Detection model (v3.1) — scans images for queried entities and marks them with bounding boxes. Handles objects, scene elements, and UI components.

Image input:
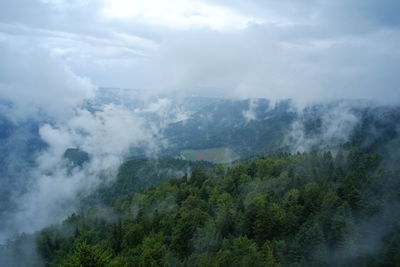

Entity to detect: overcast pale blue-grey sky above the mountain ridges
[0,0,400,103]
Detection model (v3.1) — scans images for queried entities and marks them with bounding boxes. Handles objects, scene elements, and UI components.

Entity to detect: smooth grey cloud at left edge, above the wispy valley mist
[0,44,95,118]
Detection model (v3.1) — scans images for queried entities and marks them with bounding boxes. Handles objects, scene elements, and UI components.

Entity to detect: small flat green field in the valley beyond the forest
[181,147,240,164]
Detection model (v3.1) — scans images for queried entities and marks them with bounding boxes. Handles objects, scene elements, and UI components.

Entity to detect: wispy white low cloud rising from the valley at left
[3,106,157,239]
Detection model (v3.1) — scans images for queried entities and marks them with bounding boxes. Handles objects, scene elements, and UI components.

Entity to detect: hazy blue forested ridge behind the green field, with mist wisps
[163,99,399,161]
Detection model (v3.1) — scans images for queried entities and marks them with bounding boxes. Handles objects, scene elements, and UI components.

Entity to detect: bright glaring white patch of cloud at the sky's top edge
[103,0,261,30]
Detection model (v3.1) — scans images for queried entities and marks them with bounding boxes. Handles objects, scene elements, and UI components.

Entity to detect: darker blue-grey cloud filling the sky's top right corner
[216,0,400,34]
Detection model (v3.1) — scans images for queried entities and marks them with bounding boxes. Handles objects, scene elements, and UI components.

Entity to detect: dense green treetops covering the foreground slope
[37,149,400,266]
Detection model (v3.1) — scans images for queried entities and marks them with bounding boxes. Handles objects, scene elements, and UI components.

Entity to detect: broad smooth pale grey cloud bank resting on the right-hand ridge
[134,23,400,103]
